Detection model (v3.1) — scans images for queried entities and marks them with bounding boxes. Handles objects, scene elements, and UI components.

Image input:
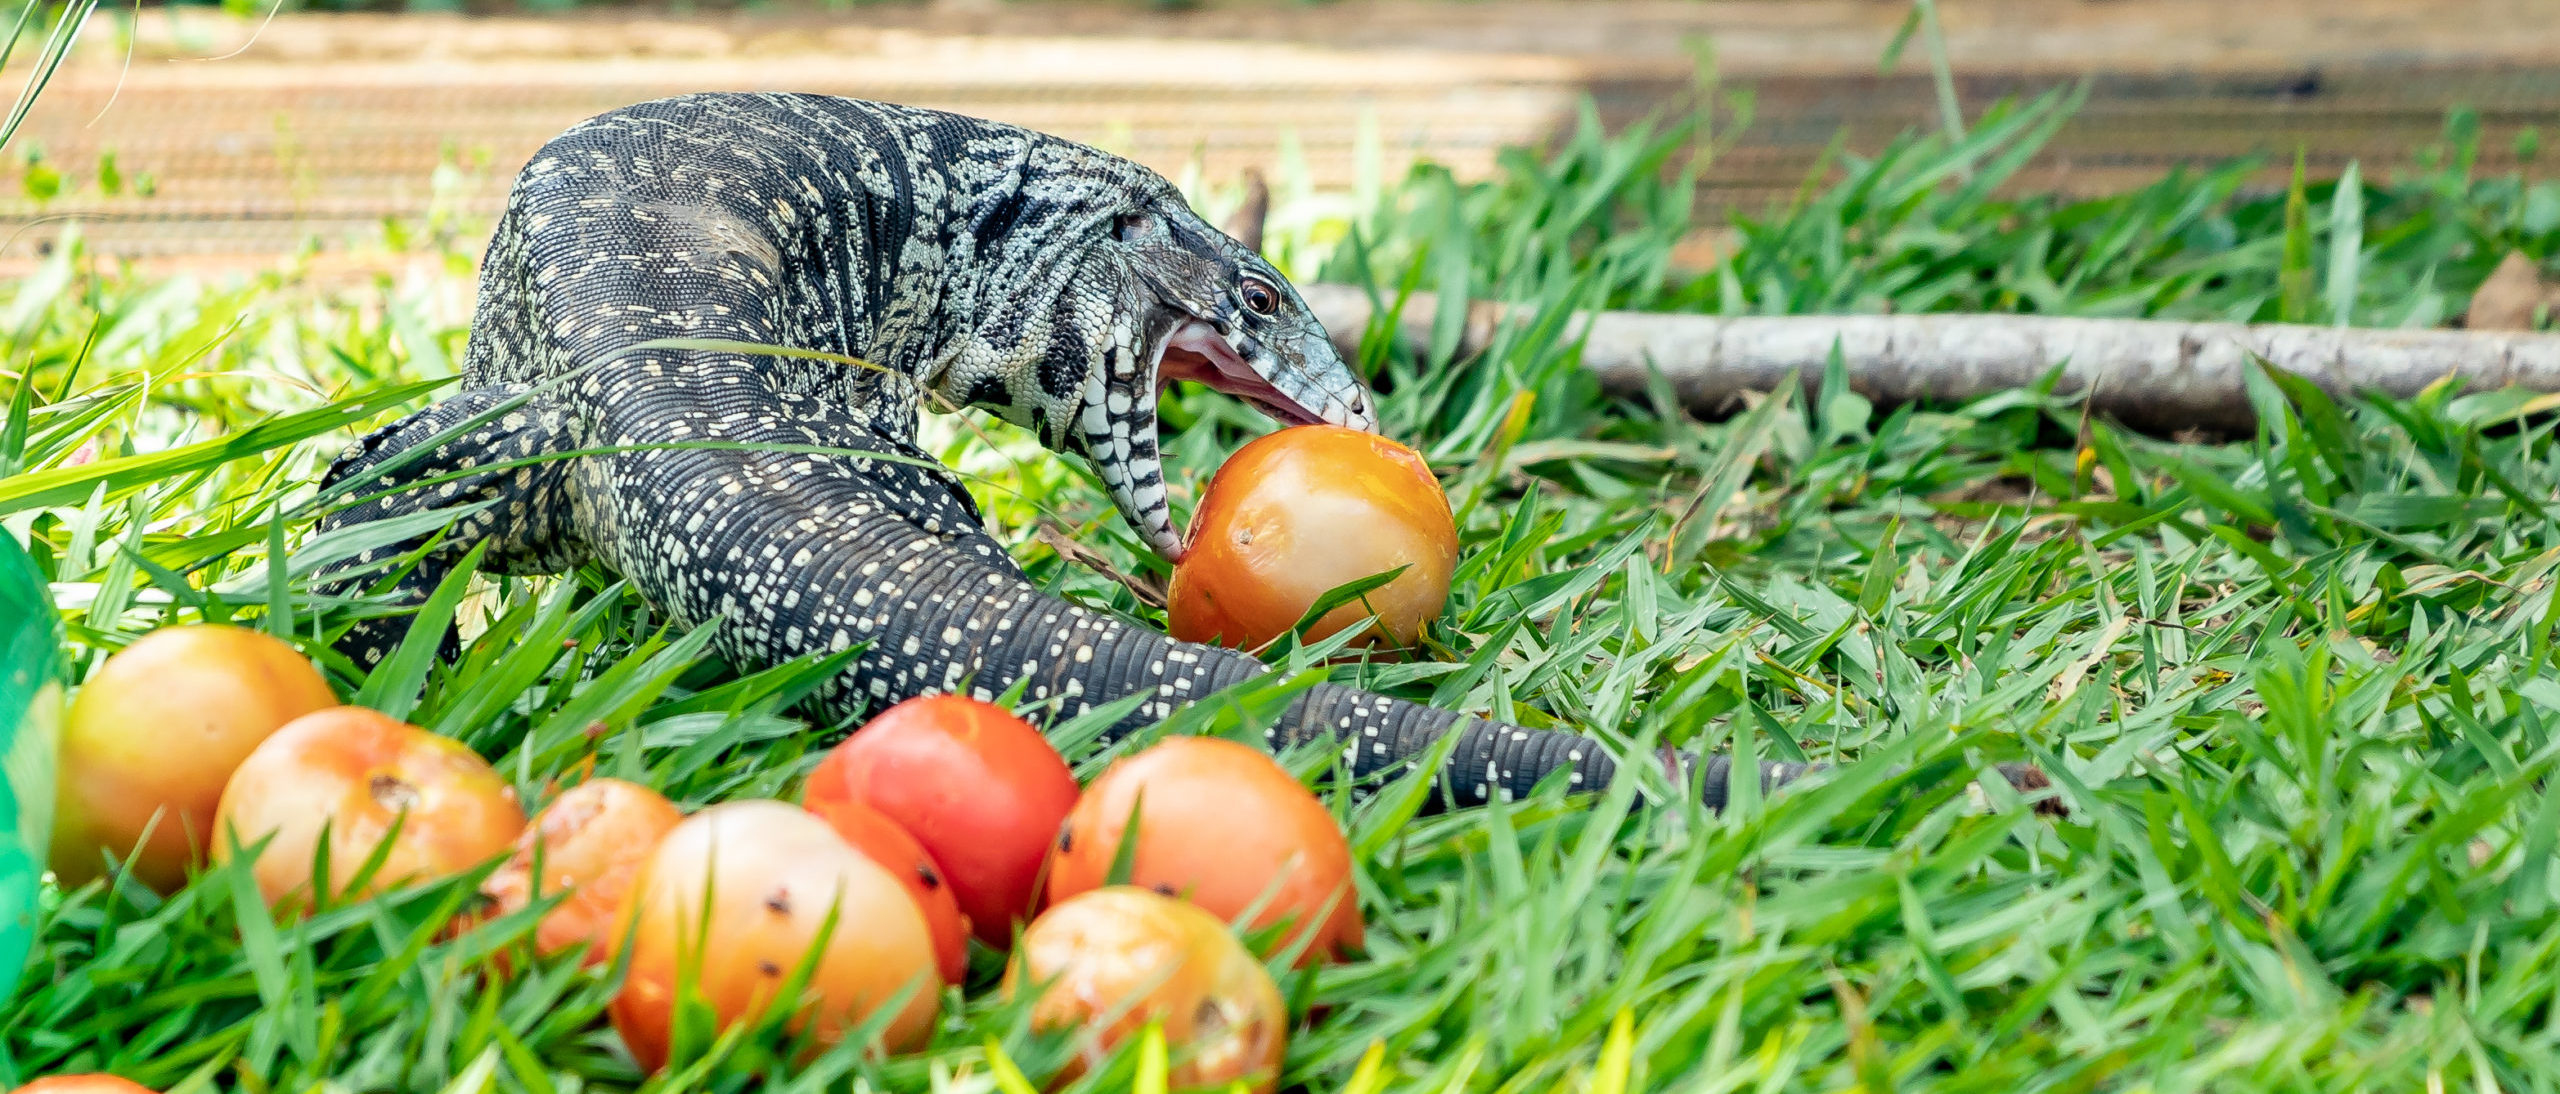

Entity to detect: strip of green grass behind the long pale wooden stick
[1326,90,2560,328]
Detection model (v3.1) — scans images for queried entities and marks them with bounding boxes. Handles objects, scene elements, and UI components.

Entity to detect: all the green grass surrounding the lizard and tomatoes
[15,79,2560,1094]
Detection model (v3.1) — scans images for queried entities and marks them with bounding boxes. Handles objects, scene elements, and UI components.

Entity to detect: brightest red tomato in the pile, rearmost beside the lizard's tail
[801,694,1075,951]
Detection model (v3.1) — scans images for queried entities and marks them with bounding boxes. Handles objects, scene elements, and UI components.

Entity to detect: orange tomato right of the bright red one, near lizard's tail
[1050,738,1362,963]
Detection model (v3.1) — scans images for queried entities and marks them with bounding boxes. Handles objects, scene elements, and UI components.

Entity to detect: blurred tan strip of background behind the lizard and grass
[0,0,2560,283]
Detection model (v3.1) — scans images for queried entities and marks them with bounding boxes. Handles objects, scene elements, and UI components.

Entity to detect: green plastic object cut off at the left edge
[0,535,64,1019]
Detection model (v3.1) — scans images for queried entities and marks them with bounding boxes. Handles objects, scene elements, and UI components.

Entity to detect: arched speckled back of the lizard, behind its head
[466,92,1170,417]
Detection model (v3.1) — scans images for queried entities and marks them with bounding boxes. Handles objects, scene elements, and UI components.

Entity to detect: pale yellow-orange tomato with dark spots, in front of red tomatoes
[612,802,942,1071]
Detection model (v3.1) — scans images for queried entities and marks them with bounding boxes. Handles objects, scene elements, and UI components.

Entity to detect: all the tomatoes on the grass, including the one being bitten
[20,428,1454,1091]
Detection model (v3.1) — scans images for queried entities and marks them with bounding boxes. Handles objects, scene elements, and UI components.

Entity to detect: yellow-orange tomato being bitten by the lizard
[1165,425,1457,648]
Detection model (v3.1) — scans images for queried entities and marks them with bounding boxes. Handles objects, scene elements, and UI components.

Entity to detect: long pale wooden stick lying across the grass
[1300,284,2560,433]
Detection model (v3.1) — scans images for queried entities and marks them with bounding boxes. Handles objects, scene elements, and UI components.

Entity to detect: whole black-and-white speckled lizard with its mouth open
[320,92,2020,810]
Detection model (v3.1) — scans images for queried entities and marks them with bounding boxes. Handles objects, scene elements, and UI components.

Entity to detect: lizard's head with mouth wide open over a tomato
[1013,187,1377,559]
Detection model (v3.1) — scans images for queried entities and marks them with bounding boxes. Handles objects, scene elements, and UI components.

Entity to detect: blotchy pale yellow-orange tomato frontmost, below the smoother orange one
[1004,886,1288,1094]
